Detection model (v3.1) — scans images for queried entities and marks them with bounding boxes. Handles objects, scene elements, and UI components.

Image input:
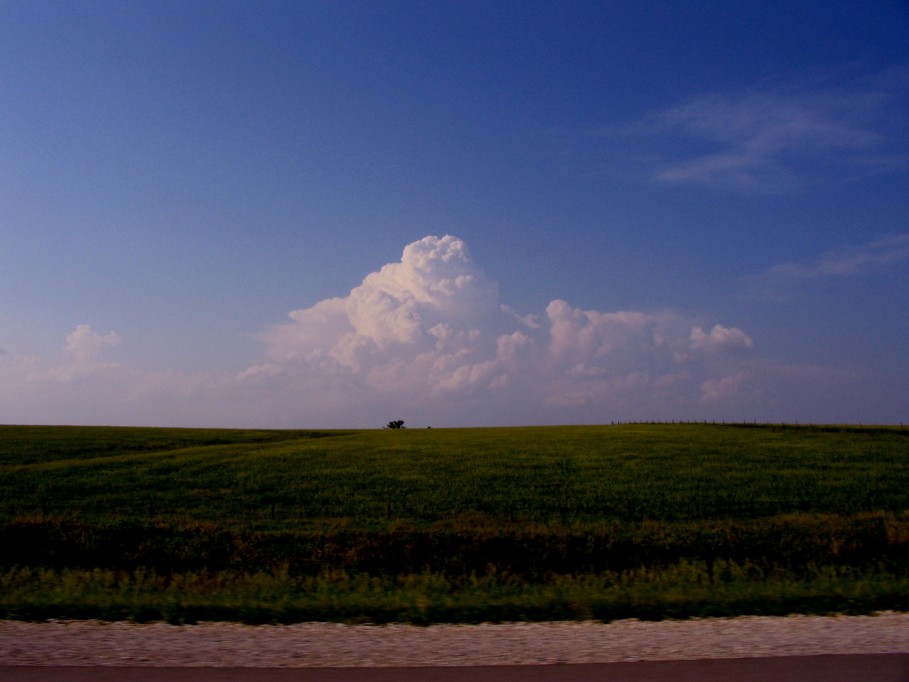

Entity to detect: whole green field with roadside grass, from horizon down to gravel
[0,424,909,623]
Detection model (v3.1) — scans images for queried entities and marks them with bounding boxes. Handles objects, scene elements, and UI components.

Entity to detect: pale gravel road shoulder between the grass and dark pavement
[0,612,909,668]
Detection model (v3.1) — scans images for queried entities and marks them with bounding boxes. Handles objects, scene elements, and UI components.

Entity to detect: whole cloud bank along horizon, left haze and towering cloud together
[0,235,888,428]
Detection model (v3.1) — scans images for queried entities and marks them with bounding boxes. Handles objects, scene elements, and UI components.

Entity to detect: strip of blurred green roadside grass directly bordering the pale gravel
[0,562,909,624]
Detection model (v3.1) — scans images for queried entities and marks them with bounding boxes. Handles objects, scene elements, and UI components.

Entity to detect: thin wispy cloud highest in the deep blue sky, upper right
[631,70,909,193]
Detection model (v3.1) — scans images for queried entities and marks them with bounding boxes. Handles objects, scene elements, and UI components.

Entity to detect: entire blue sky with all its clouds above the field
[0,0,909,427]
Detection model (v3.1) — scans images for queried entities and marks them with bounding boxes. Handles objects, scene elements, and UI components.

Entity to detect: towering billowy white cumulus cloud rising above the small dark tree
[240,235,753,422]
